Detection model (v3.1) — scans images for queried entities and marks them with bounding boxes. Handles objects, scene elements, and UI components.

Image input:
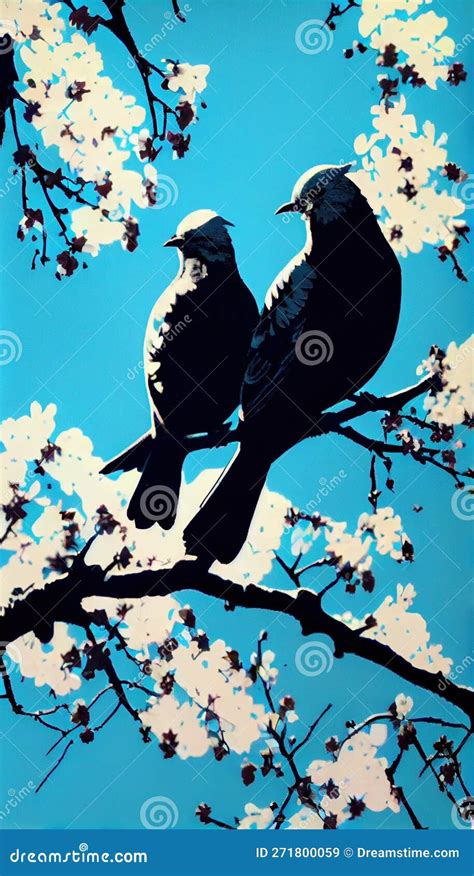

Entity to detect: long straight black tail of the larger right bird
[183,447,271,563]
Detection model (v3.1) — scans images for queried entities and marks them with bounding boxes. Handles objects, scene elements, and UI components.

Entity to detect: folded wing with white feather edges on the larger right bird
[242,252,316,419]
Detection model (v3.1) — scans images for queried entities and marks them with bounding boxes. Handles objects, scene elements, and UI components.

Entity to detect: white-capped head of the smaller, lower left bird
[163,210,234,263]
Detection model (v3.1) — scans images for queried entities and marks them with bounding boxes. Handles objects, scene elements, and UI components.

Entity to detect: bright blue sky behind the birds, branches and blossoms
[0,0,472,829]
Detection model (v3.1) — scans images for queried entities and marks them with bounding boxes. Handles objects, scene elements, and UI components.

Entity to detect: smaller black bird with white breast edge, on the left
[102,210,259,530]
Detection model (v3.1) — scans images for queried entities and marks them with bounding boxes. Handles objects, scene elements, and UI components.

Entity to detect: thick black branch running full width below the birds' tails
[0,558,474,723]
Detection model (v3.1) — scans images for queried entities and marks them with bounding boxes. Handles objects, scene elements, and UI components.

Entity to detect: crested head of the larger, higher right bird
[275,163,361,224]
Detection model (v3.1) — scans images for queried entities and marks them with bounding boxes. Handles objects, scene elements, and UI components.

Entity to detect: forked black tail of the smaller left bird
[102,429,186,529]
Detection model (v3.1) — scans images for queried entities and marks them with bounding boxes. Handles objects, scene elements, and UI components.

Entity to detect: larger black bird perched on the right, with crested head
[184,163,402,564]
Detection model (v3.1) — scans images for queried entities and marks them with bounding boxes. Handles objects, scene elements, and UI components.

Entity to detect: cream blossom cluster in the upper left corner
[0,0,210,270]
